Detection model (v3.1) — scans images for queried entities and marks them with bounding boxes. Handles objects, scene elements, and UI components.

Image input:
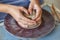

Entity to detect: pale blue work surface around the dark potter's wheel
[0,6,60,40]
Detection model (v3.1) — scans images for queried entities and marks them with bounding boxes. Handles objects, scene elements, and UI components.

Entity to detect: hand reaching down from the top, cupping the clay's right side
[28,0,42,22]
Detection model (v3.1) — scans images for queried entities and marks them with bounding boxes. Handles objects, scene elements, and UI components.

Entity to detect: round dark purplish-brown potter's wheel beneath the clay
[4,9,55,38]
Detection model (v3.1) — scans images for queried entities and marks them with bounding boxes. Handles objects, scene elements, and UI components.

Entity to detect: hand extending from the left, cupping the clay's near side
[5,5,36,28]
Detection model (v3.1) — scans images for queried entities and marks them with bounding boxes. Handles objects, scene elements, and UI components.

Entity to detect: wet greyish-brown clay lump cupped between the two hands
[21,10,42,29]
